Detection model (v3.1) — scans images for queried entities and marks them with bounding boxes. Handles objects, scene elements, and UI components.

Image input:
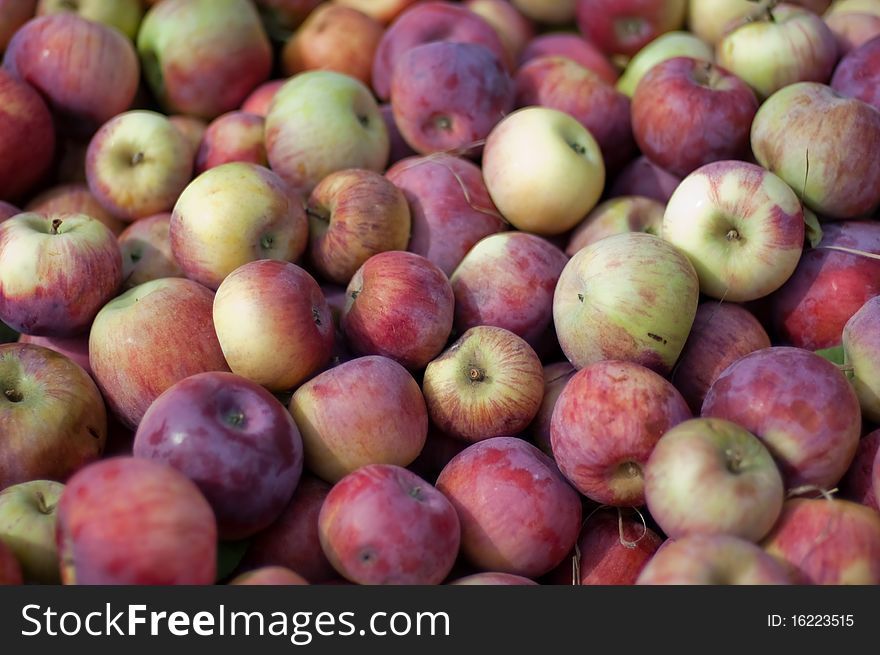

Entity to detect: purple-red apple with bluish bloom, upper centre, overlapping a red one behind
[390,41,514,154]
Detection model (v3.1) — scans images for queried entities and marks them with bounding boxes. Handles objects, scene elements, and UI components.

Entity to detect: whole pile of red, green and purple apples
[0,0,880,584]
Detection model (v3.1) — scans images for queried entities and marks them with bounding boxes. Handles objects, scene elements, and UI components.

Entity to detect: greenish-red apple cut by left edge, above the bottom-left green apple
[0,343,107,489]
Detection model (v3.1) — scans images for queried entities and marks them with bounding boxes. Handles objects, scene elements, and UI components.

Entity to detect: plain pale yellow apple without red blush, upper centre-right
[483,107,605,236]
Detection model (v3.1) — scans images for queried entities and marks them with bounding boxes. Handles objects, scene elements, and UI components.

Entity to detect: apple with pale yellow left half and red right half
[213,259,334,391]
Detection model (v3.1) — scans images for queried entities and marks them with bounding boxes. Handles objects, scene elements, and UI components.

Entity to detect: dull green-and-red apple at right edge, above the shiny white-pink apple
[752,82,880,219]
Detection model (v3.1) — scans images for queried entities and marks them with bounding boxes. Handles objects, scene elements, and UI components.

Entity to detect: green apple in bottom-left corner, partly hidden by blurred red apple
[0,480,64,584]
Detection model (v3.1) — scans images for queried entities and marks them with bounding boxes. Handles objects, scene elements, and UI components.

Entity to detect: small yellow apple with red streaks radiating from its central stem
[422,325,544,442]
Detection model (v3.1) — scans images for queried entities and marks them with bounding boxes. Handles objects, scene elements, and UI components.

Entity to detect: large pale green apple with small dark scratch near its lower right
[553,232,699,375]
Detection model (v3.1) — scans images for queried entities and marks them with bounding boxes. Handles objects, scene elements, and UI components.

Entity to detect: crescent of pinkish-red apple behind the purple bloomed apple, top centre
[372,2,512,100]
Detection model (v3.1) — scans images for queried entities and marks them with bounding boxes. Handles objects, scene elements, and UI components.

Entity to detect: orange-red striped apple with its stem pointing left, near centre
[306,168,411,285]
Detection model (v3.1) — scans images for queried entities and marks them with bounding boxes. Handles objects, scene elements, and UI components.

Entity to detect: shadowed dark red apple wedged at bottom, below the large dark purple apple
[239,472,338,584]
